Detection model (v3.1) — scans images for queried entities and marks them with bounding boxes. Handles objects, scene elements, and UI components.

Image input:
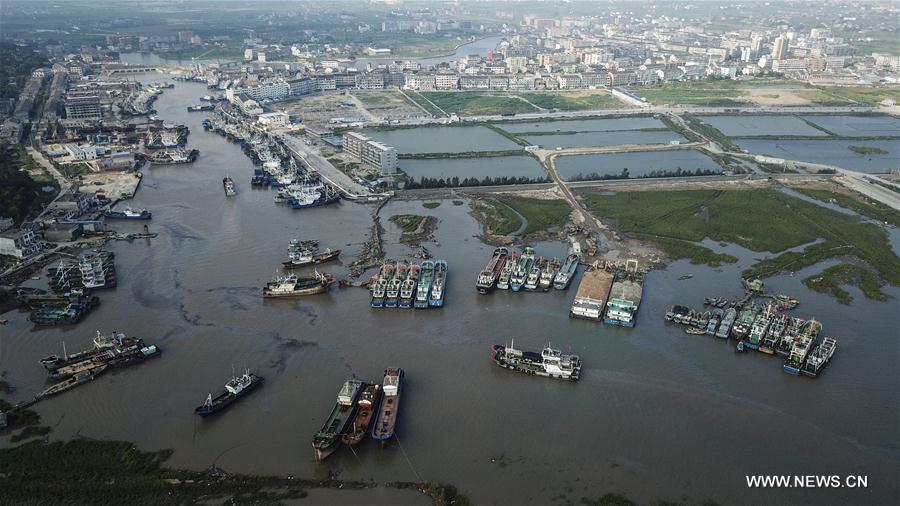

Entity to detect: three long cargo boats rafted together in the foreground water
[312,367,405,461]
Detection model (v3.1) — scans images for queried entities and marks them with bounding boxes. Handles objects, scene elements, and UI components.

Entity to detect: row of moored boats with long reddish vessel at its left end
[475,246,578,294]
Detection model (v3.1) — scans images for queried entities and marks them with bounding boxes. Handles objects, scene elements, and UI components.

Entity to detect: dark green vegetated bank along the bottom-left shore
[0,439,469,506]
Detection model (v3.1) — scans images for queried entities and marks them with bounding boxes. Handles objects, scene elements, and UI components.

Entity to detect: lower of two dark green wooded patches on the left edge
[0,143,59,223]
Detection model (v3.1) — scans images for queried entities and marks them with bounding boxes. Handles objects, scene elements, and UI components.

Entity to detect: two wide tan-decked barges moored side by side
[569,260,644,328]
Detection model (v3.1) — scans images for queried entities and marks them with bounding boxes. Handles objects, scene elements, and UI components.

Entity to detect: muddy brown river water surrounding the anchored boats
[0,83,900,504]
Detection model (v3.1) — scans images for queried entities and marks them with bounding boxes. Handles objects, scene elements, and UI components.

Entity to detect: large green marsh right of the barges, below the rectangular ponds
[585,189,900,296]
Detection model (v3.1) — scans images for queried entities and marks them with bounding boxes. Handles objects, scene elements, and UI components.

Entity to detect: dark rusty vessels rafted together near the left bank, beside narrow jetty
[35,332,160,400]
